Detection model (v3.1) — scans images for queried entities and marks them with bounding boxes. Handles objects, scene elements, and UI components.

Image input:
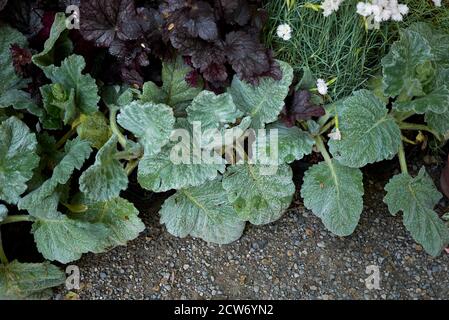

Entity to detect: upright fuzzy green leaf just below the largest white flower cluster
[382,30,434,97]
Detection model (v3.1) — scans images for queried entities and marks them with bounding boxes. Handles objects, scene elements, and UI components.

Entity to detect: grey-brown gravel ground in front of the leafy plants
[55,165,449,299]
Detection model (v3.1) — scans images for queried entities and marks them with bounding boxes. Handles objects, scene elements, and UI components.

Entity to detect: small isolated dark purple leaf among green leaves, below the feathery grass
[281,90,326,127]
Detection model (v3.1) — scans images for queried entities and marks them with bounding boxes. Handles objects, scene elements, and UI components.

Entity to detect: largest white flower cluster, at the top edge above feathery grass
[357,0,409,23]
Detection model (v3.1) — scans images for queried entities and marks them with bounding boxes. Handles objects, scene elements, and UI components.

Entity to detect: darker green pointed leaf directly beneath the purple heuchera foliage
[140,57,203,111]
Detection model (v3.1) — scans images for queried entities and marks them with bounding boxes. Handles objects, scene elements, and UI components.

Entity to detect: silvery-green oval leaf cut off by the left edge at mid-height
[0,117,39,204]
